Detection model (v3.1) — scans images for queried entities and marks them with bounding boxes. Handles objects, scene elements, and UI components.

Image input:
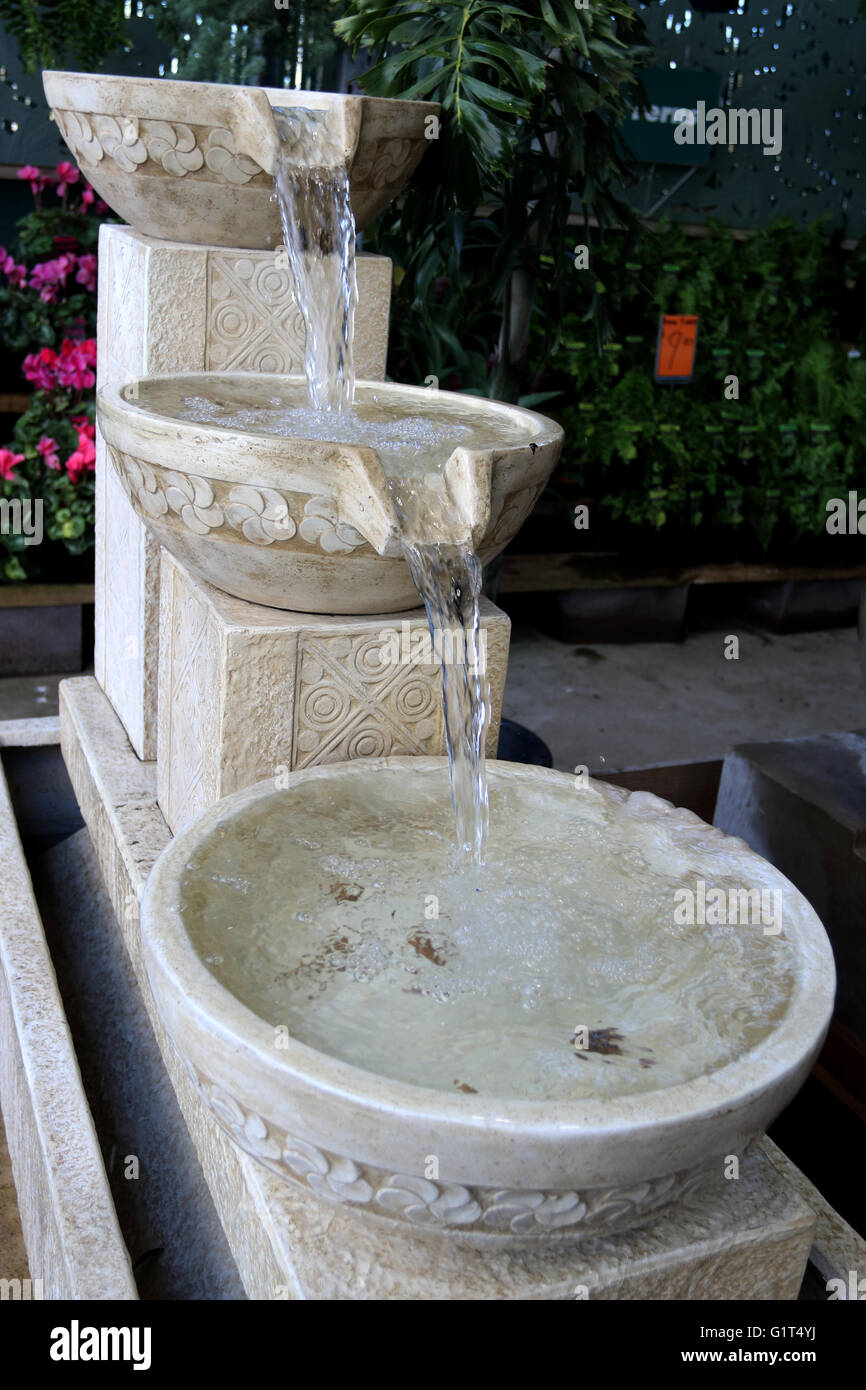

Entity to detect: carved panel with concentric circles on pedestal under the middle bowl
[292,634,442,767]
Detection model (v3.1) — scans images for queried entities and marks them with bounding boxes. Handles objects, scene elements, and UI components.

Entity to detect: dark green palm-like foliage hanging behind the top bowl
[335,0,649,398]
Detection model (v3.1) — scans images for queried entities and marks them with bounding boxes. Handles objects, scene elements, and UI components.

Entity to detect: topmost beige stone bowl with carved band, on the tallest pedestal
[43,72,439,250]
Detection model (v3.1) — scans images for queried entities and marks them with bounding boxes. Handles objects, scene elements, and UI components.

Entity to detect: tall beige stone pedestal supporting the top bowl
[95,225,391,759]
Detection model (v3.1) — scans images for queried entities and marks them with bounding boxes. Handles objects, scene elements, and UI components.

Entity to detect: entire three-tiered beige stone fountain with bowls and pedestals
[44,74,833,1298]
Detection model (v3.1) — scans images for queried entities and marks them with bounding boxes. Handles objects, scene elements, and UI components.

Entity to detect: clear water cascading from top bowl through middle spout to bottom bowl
[274,107,489,865]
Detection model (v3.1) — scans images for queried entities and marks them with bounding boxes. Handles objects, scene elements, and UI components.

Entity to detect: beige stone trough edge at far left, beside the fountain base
[0,745,138,1300]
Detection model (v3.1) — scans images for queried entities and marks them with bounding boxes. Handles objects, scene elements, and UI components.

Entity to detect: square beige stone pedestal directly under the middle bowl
[157,550,512,833]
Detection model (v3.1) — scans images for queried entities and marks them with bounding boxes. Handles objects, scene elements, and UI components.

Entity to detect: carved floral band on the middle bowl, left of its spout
[108,448,367,555]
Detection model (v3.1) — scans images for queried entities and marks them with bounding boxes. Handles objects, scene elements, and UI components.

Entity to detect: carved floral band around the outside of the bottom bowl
[185,1062,708,1240]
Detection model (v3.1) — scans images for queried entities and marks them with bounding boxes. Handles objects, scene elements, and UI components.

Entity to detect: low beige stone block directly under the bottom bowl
[261,1148,815,1301]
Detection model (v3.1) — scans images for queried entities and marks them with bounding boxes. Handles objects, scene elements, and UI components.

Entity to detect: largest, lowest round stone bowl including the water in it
[142,759,834,1245]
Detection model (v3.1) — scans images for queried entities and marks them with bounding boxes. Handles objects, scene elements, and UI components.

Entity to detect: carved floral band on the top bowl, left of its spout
[54,111,267,183]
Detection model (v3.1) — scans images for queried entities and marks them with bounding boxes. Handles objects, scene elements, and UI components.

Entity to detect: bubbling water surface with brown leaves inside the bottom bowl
[181,766,796,1099]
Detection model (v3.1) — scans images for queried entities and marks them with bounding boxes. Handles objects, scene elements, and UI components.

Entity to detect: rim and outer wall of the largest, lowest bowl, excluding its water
[142,758,835,1238]
